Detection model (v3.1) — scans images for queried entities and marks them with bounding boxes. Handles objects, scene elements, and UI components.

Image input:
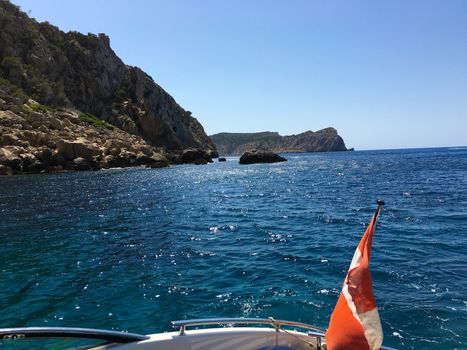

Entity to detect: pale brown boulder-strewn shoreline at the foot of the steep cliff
[0,89,217,175]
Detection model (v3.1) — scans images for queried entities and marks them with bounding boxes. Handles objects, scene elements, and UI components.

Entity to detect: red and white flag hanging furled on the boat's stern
[326,206,383,350]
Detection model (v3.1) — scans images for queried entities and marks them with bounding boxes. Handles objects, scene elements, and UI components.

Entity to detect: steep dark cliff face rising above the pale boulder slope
[0,1,215,151]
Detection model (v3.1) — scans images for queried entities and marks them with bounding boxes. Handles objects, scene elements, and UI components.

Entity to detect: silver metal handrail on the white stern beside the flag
[172,317,325,336]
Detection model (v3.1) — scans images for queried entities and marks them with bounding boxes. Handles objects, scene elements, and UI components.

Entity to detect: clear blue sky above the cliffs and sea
[13,0,467,149]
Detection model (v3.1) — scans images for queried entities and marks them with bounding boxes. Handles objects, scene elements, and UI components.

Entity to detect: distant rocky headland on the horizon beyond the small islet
[210,128,347,155]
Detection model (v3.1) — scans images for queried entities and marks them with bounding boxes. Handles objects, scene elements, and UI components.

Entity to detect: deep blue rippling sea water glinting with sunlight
[0,148,467,349]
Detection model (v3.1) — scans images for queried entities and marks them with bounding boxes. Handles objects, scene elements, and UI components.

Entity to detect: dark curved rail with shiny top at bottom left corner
[0,327,149,343]
